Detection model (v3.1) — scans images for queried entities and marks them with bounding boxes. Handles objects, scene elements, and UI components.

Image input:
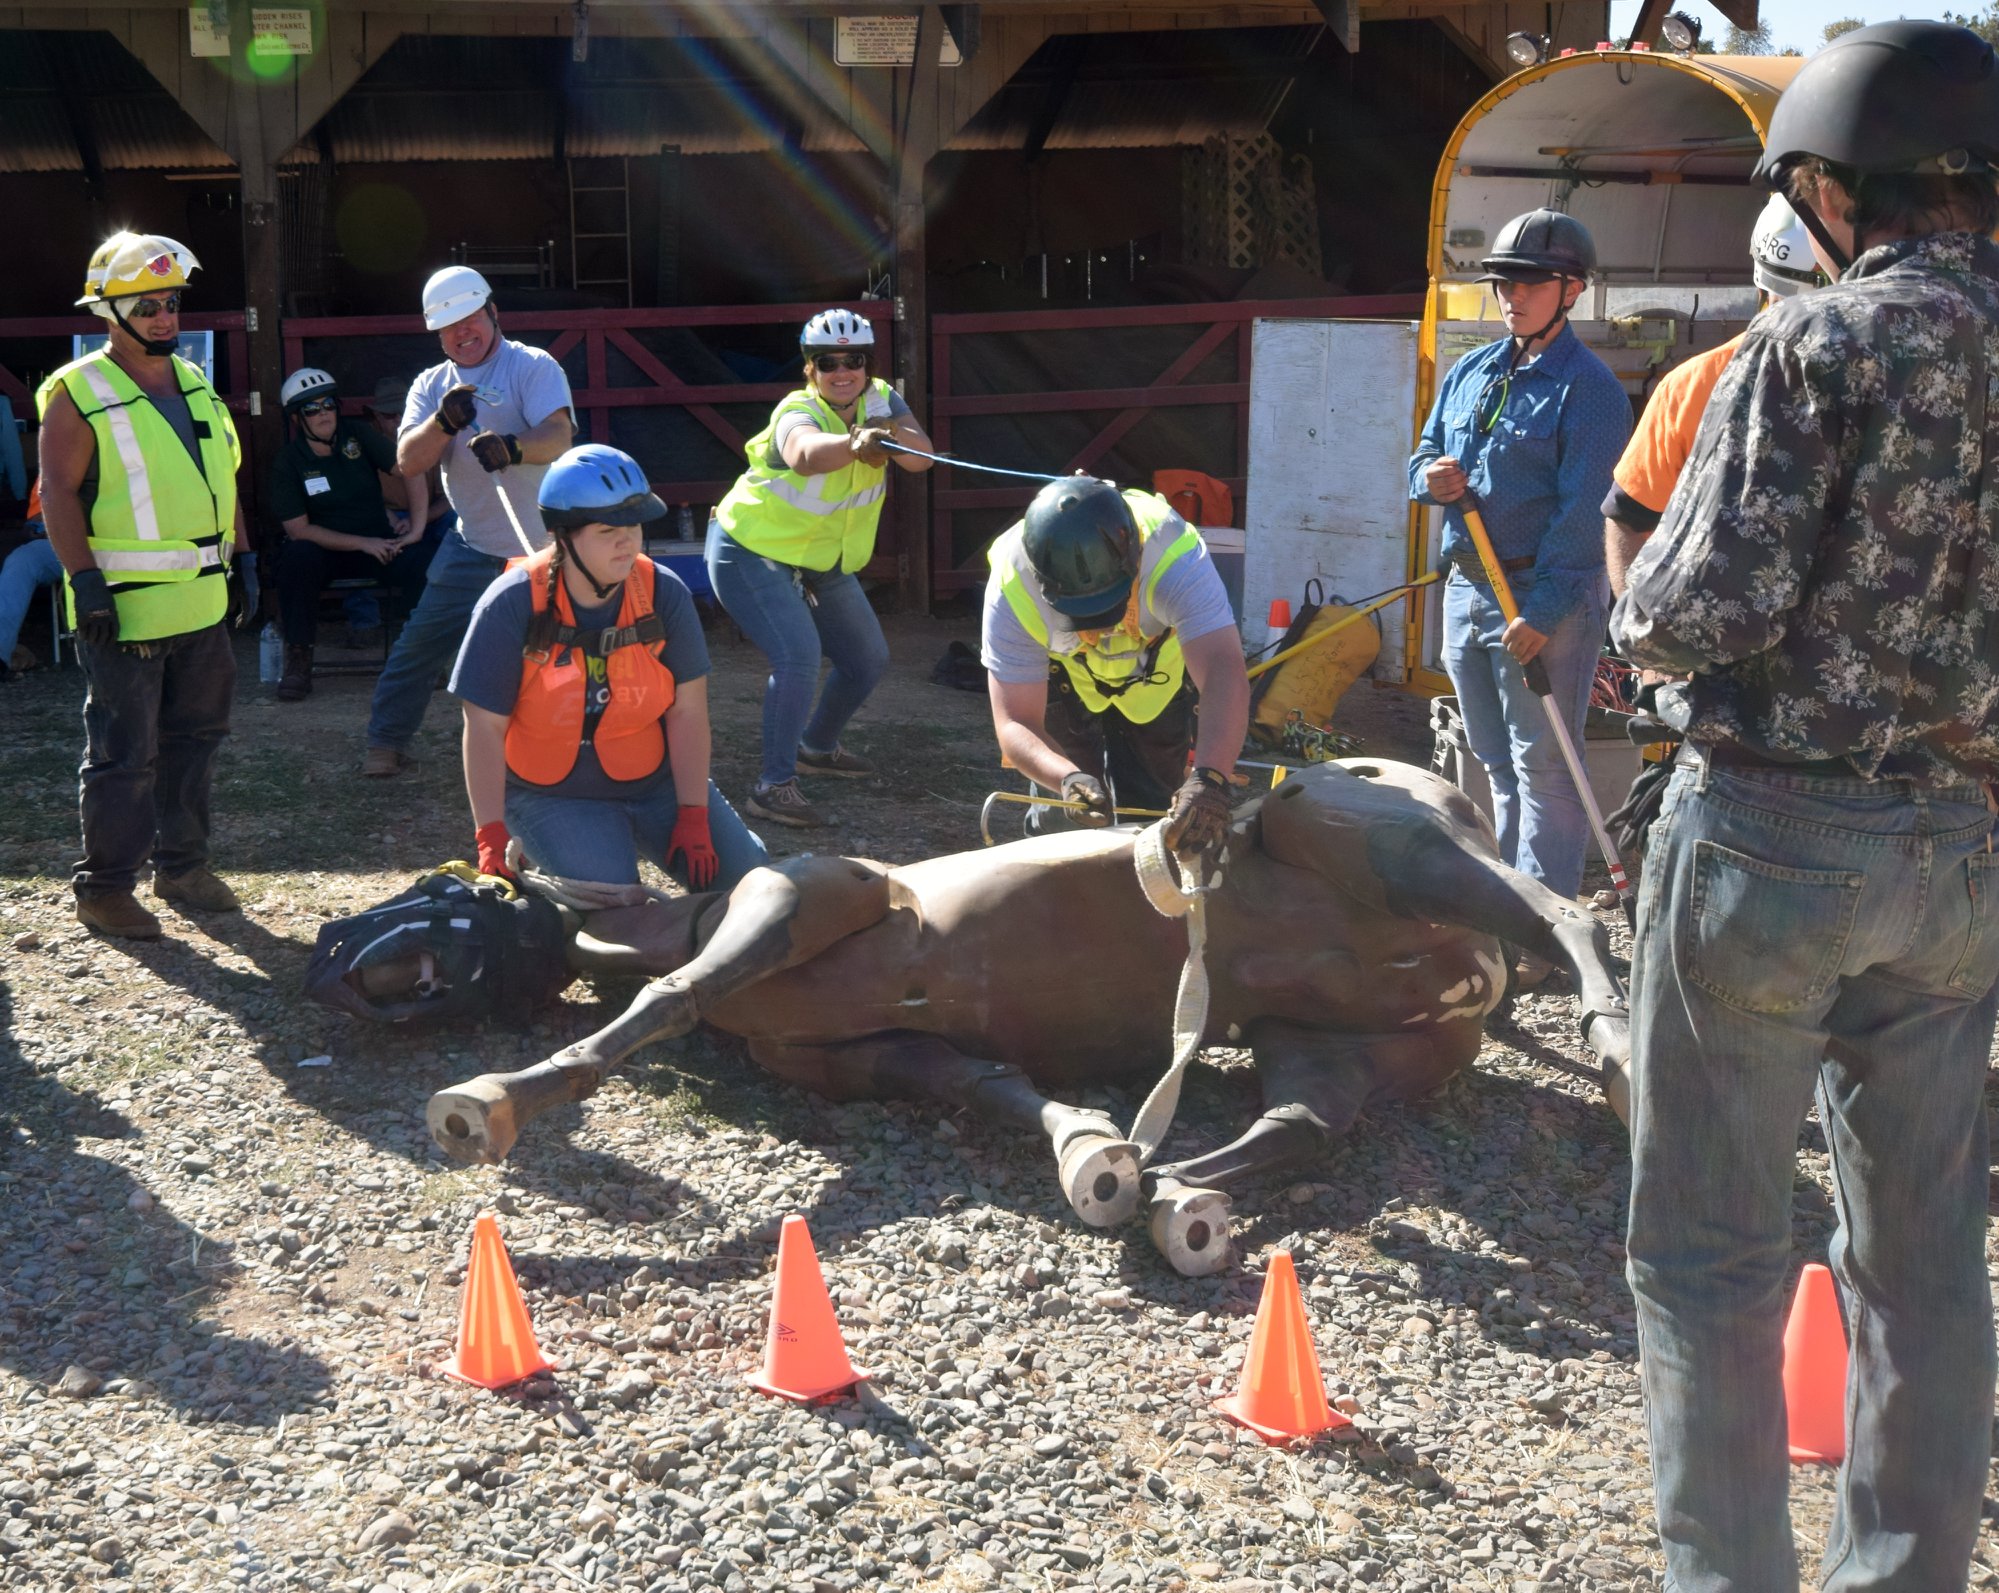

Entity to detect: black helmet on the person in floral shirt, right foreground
[1755,22,1999,188]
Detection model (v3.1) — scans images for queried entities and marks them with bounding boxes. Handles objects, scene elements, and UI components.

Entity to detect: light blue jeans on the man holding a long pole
[1443,574,1609,897]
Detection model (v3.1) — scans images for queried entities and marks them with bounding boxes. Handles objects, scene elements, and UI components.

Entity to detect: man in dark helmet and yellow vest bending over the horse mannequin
[980,476,1249,851]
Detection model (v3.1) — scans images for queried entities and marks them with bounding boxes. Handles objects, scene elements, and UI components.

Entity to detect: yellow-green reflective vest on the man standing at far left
[34,348,242,642]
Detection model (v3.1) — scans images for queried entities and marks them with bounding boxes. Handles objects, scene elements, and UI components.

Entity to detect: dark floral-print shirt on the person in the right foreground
[1613,232,1999,786]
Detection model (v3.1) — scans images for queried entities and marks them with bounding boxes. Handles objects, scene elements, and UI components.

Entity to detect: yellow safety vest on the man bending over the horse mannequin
[986,488,1201,726]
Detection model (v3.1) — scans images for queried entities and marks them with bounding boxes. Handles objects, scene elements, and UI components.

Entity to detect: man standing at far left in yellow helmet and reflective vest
[34,232,242,939]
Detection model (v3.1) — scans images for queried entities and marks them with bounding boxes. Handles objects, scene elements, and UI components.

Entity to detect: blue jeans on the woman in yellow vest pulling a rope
[706,520,888,786]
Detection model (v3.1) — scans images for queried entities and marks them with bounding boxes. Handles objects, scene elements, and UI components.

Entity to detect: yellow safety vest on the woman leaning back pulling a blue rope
[716,378,896,574]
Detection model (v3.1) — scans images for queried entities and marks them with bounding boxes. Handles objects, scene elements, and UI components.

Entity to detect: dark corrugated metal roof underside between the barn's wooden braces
[0,28,1313,172]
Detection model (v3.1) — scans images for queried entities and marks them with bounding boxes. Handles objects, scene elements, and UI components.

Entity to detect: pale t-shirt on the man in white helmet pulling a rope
[396,338,574,558]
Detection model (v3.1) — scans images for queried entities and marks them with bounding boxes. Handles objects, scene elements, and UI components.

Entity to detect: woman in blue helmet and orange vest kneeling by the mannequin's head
[452,446,766,889]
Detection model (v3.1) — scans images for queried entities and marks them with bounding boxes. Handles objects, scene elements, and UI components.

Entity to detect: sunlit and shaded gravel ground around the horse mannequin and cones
[0,620,1999,1593]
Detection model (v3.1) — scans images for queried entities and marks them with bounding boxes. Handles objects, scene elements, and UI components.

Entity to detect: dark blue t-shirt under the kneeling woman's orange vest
[452,564,708,799]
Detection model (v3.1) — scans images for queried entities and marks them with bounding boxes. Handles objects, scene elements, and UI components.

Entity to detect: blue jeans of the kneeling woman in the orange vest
[506,780,770,891]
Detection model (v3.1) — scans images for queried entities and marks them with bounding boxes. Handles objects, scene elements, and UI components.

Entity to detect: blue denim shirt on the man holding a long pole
[1409,326,1631,636]
